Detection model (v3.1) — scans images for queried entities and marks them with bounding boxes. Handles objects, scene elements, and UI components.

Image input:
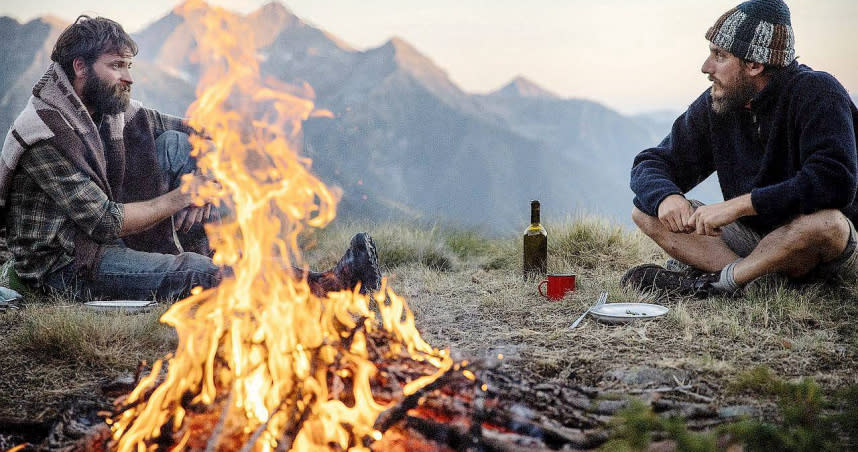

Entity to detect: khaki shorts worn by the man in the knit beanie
[690,199,858,282]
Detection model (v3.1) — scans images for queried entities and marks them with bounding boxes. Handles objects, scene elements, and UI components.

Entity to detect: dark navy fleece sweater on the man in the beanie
[631,62,858,234]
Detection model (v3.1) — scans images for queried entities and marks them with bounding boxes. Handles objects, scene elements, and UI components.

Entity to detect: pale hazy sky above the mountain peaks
[0,0,858,113]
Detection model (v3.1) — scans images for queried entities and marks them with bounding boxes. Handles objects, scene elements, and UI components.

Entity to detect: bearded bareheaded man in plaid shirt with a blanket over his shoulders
[0,16,381,300]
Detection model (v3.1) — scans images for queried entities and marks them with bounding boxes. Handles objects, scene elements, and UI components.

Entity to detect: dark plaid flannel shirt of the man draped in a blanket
[6,108,190,287]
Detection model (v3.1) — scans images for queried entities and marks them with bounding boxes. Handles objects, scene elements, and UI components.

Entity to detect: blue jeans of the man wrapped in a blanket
[43,131,222,300]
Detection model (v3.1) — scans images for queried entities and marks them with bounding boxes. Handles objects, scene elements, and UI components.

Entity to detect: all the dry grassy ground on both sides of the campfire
[0,218,858,450]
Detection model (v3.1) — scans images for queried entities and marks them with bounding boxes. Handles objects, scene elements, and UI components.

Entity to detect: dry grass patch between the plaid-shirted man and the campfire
[0,300,176,421]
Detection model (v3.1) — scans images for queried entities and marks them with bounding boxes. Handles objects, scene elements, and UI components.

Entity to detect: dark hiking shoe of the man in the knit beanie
[620,264,720,298]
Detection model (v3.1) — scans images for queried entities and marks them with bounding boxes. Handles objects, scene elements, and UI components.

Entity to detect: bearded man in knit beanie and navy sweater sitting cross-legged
[622,0,858,297]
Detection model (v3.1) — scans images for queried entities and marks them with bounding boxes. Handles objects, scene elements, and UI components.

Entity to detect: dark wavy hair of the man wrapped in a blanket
[51,15,137,81]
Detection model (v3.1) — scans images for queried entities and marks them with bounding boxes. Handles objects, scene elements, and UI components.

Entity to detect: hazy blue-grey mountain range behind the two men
[0,2,736,231]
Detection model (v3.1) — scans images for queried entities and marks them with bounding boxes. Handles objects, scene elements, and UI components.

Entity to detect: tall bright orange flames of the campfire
[109,0,452,451]
